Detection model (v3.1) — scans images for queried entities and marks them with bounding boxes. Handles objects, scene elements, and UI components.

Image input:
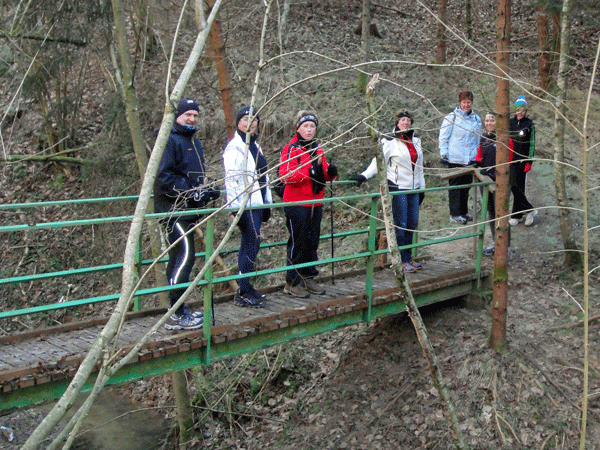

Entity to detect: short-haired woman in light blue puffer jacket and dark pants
[439,91,481,225]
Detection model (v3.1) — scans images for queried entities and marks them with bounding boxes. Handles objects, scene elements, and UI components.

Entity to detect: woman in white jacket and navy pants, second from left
[223,106,273,308]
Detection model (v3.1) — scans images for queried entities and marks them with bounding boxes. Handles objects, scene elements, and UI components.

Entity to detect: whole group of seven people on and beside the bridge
[154,91,536,330]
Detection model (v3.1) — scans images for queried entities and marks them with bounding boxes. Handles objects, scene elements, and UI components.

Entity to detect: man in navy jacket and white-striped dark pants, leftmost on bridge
[154,98,220,330]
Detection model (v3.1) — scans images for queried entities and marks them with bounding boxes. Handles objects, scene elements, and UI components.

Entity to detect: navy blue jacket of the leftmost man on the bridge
[154,122,206,219]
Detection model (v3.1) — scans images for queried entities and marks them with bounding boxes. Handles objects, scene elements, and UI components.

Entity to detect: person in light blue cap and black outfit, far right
[508,95,537,227]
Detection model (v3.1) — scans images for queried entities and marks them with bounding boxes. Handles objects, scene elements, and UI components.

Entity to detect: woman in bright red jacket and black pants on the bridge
[279,111,338,298]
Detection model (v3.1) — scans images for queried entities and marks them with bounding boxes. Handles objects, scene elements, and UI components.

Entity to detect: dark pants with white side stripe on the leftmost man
[165,218,196,313]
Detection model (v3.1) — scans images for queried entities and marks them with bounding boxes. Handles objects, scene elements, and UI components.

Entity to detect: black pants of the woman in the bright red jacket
[284,206,323,286]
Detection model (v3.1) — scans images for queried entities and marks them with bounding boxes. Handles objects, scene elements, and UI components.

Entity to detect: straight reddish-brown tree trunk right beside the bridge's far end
[488,0,510,351]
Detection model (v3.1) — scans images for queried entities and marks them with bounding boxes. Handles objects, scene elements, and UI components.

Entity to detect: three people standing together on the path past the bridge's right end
[439,91,537,255]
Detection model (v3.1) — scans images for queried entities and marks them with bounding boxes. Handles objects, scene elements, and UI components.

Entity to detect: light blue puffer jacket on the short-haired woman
[439,107,481,165]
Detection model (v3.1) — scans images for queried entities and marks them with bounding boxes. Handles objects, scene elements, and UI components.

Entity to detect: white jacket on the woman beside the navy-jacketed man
[223,132,273,208]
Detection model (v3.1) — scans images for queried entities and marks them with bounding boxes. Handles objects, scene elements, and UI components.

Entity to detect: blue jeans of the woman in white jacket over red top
[390,188,419,263]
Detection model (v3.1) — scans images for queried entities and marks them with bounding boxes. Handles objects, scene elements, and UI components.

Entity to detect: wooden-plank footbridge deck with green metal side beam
[0,181,488,411]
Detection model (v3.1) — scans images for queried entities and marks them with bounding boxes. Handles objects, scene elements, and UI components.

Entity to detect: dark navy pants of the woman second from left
[238,209,262,294]
